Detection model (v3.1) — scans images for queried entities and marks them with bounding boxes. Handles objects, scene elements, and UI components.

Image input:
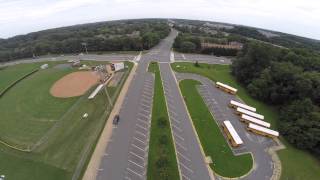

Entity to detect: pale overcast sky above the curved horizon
[0,0,320,40]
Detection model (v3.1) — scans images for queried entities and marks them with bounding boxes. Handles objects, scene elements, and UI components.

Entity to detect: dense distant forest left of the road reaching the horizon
[0,19,170,62]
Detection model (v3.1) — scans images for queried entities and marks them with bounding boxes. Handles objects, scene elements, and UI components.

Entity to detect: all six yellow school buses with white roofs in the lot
[216,82,279,147]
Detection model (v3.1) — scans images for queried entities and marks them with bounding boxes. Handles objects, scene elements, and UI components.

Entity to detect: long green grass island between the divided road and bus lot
[179,79,253,178]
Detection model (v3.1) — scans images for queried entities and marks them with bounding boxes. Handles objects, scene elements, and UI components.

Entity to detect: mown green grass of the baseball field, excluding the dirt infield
[0,62,132,180]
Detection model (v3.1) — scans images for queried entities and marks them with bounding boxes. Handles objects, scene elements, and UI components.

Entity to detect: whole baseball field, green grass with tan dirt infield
[0,61,132,180]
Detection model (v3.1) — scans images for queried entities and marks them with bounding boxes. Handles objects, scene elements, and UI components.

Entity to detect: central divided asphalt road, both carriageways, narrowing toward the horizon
[97,31,214,180]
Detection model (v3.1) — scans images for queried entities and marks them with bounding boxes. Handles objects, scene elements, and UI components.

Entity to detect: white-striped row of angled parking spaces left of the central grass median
[124,76,154,180]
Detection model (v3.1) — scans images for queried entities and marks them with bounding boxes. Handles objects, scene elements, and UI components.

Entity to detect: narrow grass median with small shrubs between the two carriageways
[147,63,180,180]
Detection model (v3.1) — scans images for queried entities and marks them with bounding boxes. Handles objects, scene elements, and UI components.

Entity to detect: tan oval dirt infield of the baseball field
[50,71,99,98]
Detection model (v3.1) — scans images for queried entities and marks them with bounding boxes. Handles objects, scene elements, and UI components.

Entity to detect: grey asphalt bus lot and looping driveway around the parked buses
[176,73,276,180]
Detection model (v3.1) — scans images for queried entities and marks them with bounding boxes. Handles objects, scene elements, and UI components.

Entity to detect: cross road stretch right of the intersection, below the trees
[174,52,232,64]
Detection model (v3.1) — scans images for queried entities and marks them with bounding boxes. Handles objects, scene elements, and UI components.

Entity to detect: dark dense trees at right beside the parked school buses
[232,42,320,157]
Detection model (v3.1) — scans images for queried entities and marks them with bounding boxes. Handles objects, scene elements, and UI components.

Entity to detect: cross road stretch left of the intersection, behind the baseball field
[0,54,138,67]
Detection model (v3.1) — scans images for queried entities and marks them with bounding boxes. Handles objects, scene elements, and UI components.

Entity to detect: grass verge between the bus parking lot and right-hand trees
[171,63,320,180]
